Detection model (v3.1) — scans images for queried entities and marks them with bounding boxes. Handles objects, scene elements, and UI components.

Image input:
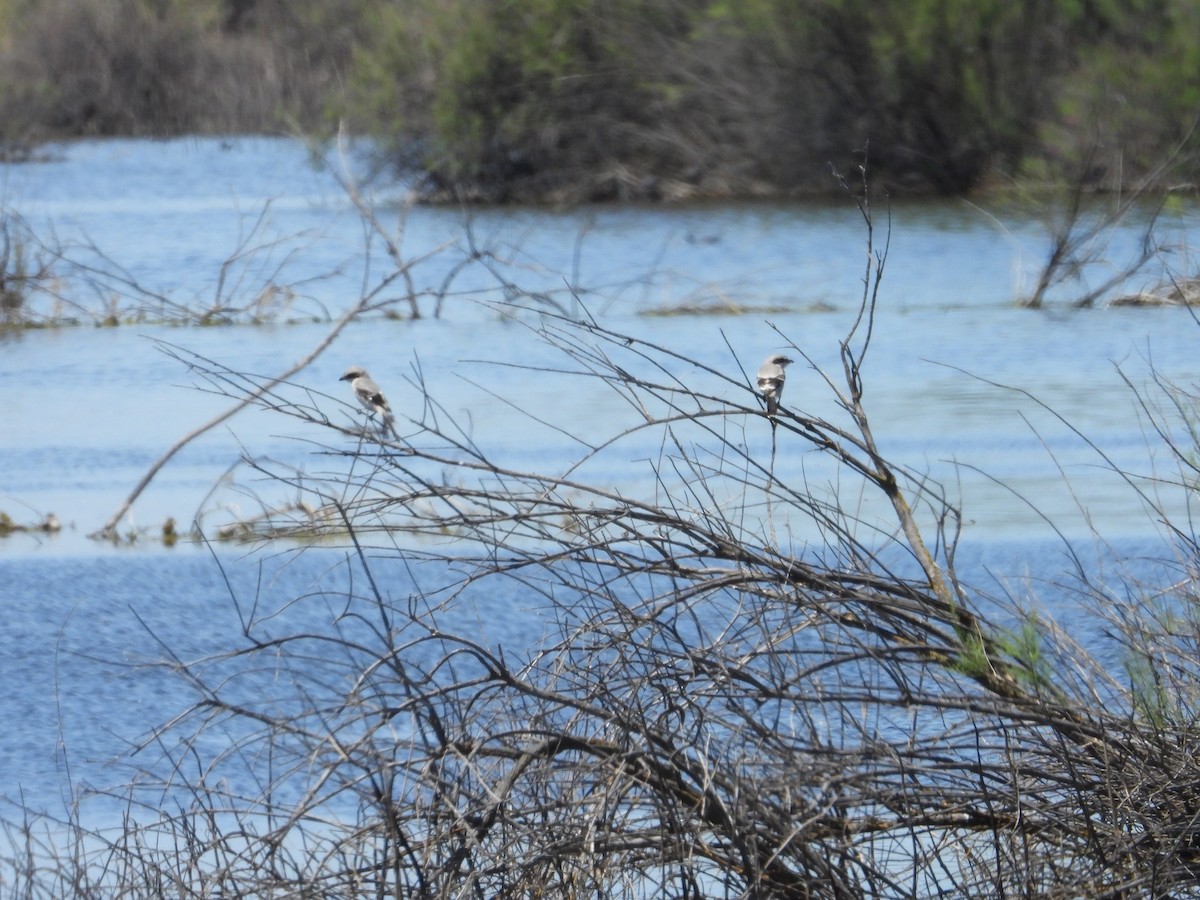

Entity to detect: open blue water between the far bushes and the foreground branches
[0,139,1200,825]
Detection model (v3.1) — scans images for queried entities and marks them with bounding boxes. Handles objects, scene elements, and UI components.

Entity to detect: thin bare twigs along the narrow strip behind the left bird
[0,158,590,329]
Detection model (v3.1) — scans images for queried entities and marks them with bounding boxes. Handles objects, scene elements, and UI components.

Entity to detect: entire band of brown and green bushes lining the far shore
[0,0,1200,200]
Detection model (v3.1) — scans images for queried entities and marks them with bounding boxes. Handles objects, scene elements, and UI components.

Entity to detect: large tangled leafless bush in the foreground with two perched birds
[7,168,1200,898]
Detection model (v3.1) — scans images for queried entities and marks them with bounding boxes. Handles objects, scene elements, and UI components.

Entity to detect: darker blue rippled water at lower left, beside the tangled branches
[0,548,546,812]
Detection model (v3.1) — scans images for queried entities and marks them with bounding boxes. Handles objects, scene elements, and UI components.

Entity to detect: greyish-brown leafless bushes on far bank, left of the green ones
[0,0,367,146]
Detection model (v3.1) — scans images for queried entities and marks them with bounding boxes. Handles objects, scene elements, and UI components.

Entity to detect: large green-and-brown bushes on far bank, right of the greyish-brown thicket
[336,0,1198,199]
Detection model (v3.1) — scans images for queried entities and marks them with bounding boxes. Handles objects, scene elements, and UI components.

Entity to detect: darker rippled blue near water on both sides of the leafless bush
[0,541,1182,823]
